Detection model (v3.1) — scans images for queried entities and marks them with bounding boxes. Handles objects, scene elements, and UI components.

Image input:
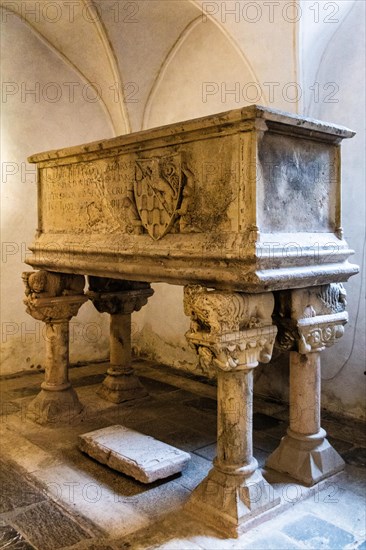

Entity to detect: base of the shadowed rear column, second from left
[97,369,148,403]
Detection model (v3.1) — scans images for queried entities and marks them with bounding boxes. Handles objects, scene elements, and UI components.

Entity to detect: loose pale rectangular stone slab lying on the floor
[79,425,191,483]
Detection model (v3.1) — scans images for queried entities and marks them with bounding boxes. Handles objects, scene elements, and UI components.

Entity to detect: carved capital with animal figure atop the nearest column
[184,286,277,376]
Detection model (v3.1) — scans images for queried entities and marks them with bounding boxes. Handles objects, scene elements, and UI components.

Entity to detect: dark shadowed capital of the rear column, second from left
[86,277,154,315]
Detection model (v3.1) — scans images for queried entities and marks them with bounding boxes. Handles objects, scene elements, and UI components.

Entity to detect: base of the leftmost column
[27,385,84,424]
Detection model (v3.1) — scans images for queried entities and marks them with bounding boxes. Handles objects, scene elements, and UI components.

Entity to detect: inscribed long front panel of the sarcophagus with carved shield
[40,136,240,241]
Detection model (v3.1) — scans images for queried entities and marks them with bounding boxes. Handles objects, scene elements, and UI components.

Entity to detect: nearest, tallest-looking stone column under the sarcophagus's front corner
[185,286,280,536]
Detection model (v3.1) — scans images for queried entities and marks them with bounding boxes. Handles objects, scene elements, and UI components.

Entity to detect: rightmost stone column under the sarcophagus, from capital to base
[266,284,348,485]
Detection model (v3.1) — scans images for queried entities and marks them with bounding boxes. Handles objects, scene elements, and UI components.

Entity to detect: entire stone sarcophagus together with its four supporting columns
[23,106,358,535]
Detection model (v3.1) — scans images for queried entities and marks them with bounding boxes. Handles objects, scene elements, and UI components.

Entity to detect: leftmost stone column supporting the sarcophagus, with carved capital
[23,271,87,424]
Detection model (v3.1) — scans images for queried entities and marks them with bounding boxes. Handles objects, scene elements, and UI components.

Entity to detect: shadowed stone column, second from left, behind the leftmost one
[87,277,154,403]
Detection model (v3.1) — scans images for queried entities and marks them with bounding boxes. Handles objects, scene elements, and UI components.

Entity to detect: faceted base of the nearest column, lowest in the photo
[185,468,281,537]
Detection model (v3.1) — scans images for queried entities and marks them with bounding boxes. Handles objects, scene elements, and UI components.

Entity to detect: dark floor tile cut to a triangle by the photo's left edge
[0,461,45,513]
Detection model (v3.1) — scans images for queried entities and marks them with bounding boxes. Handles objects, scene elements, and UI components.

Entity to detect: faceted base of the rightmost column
[266,428,345,486]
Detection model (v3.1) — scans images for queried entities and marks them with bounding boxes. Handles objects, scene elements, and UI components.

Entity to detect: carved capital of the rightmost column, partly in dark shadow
[275,283,348,354]
